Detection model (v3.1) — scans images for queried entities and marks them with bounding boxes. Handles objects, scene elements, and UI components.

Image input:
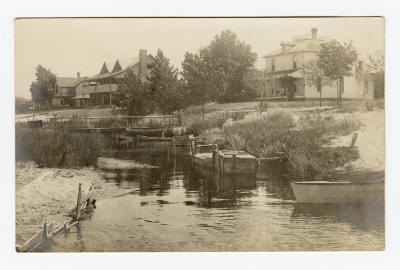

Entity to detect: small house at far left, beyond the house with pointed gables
[52,72,84,107]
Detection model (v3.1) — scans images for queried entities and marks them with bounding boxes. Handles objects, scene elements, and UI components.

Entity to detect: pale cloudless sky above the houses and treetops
[15,17,384,98]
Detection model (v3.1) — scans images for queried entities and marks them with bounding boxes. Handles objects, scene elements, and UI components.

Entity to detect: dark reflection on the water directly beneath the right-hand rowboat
[292,202,385,231]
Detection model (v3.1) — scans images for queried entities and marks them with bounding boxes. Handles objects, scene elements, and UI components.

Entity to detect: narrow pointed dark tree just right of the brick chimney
[149,49,185,114]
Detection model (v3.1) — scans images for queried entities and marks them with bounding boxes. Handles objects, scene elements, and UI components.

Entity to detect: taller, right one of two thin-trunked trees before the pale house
[319,39,357,104]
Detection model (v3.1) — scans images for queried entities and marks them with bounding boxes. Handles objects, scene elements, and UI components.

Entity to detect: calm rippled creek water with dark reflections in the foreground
[42,144,384,251]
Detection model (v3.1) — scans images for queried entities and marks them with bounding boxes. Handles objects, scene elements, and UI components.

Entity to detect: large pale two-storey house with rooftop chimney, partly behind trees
[261,28,374,100]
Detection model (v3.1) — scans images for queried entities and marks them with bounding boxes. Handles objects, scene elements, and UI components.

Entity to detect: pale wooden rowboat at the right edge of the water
[290,180,385,204]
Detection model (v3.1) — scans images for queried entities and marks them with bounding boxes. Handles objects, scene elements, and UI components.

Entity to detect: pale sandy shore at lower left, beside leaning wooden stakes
[15,163,102,244]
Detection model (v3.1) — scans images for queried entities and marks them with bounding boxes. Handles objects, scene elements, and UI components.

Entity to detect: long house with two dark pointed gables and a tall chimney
[73,50,155,107]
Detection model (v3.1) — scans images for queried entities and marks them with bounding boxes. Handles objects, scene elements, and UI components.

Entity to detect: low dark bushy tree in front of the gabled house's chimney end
[113,69,153,115]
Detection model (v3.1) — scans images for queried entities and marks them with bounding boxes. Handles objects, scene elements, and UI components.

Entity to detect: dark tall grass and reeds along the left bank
[15,124,111,168]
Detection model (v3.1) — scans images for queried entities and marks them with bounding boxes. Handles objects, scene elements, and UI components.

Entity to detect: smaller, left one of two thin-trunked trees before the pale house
[304,60,332,107]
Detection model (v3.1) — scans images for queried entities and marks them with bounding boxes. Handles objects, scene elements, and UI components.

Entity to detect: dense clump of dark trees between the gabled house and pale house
[113,30,257,115]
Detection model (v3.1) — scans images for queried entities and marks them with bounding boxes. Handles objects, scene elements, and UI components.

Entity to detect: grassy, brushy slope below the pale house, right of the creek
[199,110,361,180]
